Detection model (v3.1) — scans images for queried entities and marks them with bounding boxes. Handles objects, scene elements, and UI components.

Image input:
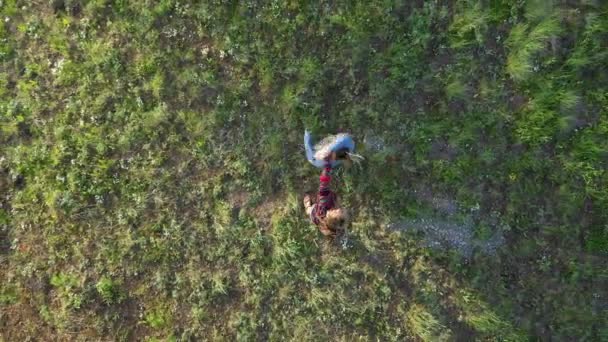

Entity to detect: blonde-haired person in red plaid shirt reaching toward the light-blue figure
[304,149,350,237]
